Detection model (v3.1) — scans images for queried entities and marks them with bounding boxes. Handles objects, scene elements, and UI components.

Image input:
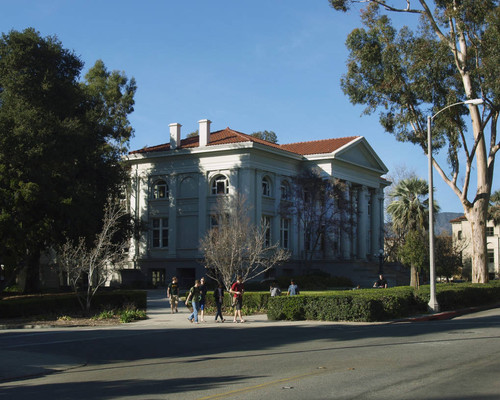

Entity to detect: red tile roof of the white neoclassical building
[129,128,359,155]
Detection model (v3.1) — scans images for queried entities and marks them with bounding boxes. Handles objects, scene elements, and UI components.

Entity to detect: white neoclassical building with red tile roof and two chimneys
[126,120,389,285]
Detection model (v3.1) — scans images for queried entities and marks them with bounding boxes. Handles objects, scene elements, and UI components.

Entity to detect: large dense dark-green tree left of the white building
[0,28,136,291]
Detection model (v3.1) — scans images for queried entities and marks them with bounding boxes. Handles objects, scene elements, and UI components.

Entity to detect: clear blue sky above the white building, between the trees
[0,0,492,212]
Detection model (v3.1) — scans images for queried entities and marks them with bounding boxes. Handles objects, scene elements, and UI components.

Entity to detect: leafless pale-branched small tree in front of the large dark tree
[57,199,129,312]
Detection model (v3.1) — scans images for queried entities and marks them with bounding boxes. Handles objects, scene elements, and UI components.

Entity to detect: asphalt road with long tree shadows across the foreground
[0,290,500,400]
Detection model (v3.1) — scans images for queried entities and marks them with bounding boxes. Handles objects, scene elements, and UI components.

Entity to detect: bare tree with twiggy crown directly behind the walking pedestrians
[201,195,289,290]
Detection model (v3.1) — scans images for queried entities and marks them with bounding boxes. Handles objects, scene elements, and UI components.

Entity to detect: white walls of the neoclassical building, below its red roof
[124,136,385,284]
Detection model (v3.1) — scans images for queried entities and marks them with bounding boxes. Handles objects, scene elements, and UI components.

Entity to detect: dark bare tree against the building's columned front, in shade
[280,169,353,265]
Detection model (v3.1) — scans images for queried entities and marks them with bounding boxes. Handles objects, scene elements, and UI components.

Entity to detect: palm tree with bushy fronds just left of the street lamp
[387,177,439,288]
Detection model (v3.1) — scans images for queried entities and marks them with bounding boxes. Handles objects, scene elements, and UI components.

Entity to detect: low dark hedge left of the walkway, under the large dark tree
[0,290,147,318]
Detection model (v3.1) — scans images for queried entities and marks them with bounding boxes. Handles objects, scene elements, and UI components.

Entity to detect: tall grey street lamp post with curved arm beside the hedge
[427,99,483,312]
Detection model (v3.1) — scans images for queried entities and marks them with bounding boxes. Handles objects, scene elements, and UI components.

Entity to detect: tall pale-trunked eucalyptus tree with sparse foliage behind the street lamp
[329,0,500,283]
